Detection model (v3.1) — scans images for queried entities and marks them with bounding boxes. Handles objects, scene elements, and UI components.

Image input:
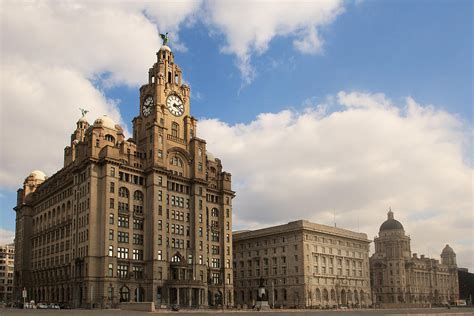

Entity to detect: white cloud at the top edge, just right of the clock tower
[205,0,343,84]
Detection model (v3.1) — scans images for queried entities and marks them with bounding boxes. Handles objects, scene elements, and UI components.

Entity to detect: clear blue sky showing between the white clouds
[105,1,472,128]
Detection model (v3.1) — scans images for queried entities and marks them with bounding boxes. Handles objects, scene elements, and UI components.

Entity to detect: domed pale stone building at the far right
[370,210,459,307]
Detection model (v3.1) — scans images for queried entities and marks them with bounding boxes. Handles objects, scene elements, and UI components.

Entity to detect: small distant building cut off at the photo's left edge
[0,244,15,302]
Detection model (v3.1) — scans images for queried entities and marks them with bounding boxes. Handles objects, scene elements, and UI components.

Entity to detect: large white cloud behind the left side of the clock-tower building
[0,0,200,189]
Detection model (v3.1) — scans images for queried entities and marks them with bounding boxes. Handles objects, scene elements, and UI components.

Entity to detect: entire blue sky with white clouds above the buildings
[0,0,474,270]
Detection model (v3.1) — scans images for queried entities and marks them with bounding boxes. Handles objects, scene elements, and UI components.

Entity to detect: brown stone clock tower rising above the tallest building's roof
[133,45,198,168]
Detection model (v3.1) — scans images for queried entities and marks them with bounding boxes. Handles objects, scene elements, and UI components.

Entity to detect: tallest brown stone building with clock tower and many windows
[15,46,234,307]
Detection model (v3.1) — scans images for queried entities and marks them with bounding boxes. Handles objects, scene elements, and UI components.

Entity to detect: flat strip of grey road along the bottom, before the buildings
[0,307,474,316]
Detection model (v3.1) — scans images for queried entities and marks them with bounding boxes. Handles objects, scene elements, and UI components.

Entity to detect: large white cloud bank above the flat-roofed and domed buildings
[198,91,474,269]
